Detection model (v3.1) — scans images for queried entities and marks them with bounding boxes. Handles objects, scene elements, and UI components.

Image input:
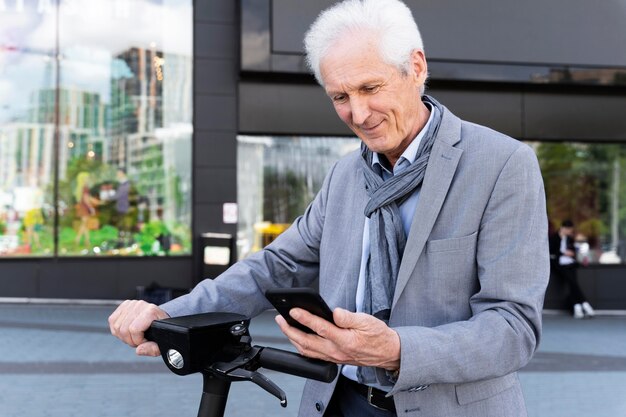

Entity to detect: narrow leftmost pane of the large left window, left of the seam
[0,1,56,256]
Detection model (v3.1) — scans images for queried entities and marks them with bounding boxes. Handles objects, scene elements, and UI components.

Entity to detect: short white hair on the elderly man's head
[304,0,424,85]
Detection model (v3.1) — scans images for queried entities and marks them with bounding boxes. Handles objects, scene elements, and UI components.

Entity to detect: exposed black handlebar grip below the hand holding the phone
[259,347,337,382]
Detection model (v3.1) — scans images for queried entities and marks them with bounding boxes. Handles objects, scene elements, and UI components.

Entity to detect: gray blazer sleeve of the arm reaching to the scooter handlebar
[160,161,336,317]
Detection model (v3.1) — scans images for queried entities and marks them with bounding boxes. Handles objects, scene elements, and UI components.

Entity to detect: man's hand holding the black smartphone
[276,308,400,371]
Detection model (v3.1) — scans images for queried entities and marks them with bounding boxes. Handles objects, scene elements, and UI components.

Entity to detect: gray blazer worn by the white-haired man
[163,104,549,417]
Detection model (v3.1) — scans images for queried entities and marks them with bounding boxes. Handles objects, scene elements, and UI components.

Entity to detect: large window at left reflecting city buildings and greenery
[0,0,193,256]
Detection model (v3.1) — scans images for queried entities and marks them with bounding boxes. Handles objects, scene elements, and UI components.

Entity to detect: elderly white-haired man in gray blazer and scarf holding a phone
[110,0,549,417]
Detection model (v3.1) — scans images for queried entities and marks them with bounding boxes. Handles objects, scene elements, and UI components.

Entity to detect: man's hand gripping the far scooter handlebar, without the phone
[109,300,169,356]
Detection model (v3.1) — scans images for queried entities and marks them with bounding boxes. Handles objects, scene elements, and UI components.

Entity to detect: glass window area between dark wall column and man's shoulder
[237,136,360,259]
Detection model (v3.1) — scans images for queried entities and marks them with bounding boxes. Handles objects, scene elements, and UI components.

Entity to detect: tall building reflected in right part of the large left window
[107,47,193,222]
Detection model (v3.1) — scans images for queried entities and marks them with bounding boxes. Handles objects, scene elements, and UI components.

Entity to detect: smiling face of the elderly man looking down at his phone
[320,35,429,164]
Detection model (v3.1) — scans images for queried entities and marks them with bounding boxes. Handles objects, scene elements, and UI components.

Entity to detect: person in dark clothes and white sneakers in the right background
[549,220,595,319]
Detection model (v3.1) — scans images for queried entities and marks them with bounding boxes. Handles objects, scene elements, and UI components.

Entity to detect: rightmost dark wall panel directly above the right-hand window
[524,93,626,140]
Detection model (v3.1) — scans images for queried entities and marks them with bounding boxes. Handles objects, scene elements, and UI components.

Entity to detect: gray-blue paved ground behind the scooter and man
[0,304,626,417]
